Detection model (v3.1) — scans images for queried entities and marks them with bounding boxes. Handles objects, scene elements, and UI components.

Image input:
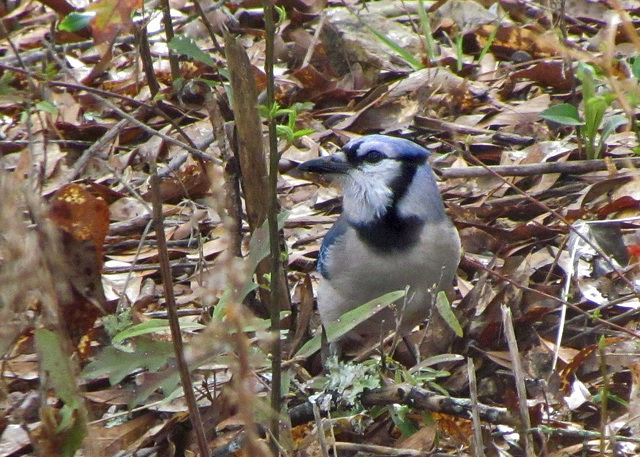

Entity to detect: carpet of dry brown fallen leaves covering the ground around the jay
[0,0,640,455]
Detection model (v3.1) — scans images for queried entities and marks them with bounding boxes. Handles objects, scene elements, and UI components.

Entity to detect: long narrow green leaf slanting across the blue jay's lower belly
[296,290,405,357]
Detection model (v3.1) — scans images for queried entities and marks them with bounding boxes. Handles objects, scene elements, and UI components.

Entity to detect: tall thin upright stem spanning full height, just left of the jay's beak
[262,0,282,452]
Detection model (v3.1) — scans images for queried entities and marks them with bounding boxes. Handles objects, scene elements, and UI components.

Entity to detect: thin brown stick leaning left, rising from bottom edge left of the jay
[149,161,209,457]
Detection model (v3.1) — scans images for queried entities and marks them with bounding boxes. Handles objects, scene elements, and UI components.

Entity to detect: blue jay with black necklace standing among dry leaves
[298,135,460,342]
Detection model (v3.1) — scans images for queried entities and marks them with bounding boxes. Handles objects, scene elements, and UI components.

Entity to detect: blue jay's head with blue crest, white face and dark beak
[298,135,444,225]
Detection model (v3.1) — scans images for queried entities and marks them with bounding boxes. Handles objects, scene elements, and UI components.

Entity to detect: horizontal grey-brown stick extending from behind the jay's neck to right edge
[439,157,640,179]
